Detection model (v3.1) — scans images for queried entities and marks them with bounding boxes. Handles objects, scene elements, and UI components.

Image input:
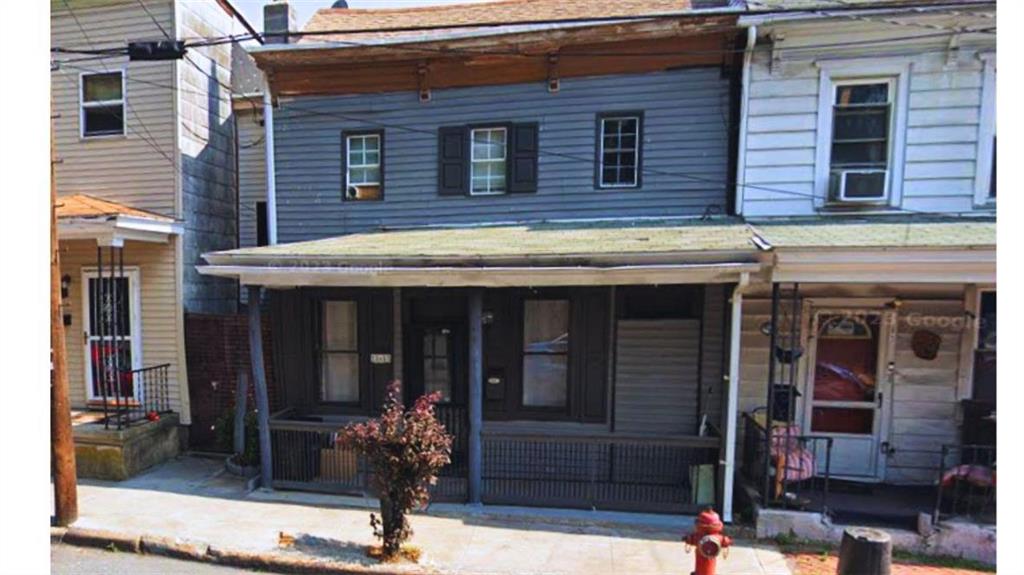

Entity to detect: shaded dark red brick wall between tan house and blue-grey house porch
[185,313,284,450]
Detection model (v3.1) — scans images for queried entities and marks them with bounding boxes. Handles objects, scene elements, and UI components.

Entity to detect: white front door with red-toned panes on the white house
[804,309,894,481]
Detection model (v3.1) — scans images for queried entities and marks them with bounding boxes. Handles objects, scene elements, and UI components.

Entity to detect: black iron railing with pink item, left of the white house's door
[740,413,833,514]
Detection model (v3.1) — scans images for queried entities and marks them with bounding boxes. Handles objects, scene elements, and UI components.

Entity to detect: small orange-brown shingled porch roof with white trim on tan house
[56,193,182,247]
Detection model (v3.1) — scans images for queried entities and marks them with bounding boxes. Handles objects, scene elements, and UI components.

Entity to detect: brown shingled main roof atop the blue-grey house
[299,0,738,44]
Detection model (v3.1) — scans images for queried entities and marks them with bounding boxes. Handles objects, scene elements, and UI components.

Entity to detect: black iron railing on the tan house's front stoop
[99,363,171,430]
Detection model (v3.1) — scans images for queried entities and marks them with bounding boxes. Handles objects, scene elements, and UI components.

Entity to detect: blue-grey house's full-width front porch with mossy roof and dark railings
[201,221,760,517]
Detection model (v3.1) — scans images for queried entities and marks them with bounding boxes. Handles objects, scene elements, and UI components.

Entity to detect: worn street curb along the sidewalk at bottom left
[50,527,413,575]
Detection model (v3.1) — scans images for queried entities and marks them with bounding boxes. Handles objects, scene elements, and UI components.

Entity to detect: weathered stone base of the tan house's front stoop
[73,413,181,481]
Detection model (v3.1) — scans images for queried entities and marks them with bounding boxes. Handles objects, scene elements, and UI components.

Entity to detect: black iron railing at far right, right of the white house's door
[932,445,995,524]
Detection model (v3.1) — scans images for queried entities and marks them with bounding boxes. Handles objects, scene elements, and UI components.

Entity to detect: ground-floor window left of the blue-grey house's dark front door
[319,301,359,403]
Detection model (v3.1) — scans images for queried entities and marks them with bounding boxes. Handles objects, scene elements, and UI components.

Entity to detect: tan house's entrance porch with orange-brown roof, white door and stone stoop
[56,190,187,479]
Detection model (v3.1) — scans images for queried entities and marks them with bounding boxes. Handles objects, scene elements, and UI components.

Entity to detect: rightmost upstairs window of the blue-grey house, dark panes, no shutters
[597,114,641,187]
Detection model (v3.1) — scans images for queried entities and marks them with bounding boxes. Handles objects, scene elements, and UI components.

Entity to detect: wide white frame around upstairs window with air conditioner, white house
[814,59,910,210]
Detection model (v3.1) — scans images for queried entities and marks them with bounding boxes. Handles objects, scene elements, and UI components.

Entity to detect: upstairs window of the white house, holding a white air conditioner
[829,80,894,203]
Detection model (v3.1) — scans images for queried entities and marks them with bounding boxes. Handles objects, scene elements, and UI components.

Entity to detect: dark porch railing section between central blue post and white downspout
[481,431,720,513]
